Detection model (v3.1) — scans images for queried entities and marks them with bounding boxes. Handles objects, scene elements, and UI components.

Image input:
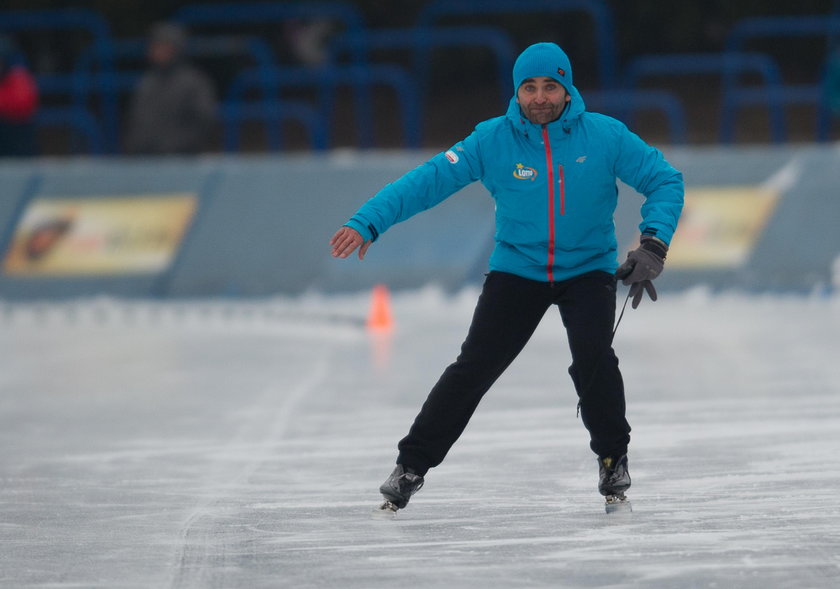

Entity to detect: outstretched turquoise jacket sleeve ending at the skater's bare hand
[345,132,483,241]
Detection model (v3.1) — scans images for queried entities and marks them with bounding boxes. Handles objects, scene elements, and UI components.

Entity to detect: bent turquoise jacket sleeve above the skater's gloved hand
[615,125,685,244]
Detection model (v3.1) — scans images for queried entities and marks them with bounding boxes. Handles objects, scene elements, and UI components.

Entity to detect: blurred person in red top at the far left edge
[0,35,38,157]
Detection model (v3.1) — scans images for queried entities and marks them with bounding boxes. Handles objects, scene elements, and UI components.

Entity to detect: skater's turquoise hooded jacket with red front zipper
[346,87,684,282]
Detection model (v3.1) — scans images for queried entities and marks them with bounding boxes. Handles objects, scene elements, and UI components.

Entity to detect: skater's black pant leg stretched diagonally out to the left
[397,272,551,474]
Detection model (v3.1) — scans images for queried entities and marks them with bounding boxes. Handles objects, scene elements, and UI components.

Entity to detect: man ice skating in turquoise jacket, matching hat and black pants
[330,43,684,511]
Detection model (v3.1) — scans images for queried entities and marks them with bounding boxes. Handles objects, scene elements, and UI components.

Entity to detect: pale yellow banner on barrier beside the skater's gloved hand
[667,186,779,268]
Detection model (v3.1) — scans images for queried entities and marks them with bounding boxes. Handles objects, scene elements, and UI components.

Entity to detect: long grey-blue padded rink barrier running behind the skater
[0,146,840,299]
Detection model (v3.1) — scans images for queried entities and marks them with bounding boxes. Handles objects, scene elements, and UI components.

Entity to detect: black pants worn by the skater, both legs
[397,272,630,474]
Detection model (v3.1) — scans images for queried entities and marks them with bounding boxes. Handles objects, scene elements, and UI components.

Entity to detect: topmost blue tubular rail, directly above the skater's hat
[417,0,616,88]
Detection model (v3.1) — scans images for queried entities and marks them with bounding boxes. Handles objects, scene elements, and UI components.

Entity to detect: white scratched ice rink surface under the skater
[0,288,840,589]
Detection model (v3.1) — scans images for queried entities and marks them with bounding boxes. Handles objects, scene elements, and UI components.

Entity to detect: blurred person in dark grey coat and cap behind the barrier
[125,23,218,155]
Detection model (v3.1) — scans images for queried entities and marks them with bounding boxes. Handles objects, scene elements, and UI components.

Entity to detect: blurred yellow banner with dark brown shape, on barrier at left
[3,194,198,276]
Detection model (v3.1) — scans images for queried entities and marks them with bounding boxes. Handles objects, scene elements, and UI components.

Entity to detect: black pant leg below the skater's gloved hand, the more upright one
[557,272,630,457]
